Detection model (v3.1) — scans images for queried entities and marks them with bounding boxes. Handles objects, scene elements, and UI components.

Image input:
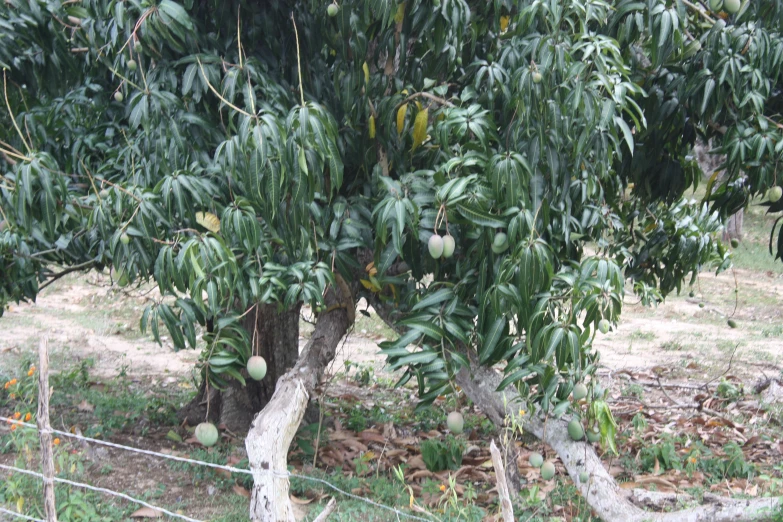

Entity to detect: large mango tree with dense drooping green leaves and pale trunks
[0,0,783,520]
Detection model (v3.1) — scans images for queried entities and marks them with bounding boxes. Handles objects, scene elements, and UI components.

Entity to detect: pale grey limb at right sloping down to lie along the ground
[457,366,783,522]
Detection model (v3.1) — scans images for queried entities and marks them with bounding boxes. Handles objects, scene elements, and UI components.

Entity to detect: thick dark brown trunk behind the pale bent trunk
[178,304,300,433]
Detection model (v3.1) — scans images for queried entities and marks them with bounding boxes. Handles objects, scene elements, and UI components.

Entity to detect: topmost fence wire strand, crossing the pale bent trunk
[0,417,433,522]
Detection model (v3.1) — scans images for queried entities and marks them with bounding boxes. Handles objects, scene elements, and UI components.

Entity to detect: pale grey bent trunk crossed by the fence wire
[245,276,354,522]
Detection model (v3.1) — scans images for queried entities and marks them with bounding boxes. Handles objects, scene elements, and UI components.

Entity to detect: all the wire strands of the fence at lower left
[0,417,434,522]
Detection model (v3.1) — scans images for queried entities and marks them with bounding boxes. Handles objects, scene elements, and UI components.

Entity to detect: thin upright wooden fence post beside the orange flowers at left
[37,337,57,522]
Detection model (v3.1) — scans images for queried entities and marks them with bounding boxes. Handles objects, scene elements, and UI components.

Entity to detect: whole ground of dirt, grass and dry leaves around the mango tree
[0,204,783,521]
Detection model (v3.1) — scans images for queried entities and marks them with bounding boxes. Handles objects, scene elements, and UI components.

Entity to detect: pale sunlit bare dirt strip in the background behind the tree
[0,270,783,378]
